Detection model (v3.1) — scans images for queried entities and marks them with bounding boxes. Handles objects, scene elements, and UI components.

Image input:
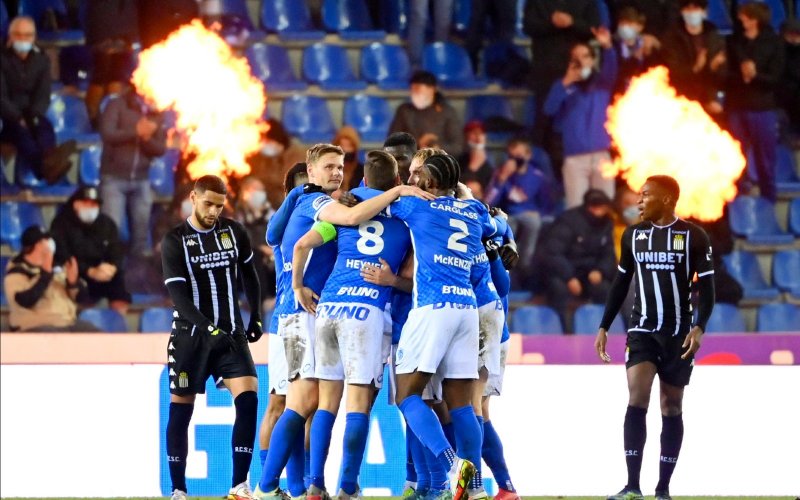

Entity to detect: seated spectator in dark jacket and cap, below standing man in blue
[536,189,617,332]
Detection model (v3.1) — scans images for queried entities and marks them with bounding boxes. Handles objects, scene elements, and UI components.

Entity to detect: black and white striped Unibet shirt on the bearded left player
[161,217,253,333]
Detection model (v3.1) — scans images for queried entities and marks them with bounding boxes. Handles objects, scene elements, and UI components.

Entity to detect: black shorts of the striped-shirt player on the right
[625,332,694,387]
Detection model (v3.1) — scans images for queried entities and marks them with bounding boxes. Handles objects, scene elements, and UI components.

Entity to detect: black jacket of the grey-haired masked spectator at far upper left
[0,45,51,122]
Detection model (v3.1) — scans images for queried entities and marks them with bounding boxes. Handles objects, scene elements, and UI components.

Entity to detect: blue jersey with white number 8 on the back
[319,187,411,309]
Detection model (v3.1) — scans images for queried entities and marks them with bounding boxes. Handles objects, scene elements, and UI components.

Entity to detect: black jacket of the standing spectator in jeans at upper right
[728,26,785,111]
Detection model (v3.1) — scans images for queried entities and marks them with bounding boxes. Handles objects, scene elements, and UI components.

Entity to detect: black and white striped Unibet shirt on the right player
[619,219,714,335]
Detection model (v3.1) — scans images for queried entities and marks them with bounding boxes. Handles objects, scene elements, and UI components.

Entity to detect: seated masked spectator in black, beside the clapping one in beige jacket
[50,186,131,314]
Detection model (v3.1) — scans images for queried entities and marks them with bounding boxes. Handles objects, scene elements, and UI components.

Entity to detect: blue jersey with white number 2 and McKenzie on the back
[387,196,497,308]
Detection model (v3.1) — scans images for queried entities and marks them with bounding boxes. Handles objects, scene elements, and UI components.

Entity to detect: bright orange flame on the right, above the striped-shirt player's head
[603,66,745,220]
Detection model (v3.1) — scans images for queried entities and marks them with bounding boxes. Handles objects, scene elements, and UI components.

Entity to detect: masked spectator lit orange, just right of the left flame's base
[248,118,306,207]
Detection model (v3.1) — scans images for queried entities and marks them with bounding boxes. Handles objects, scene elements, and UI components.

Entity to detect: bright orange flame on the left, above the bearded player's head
[133,20,267,179]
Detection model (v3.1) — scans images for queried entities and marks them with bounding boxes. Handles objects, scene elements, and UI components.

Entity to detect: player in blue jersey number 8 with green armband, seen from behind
[292,151,411,499]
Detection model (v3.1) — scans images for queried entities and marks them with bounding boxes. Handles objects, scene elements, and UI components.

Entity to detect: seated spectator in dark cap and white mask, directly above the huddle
[389,71,464,156]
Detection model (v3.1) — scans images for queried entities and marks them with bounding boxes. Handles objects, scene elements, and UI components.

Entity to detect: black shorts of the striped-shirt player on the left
[167,320,256,396]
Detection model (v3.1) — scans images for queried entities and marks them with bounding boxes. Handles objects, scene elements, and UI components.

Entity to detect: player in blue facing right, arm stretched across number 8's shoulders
[255,144,432,498]
